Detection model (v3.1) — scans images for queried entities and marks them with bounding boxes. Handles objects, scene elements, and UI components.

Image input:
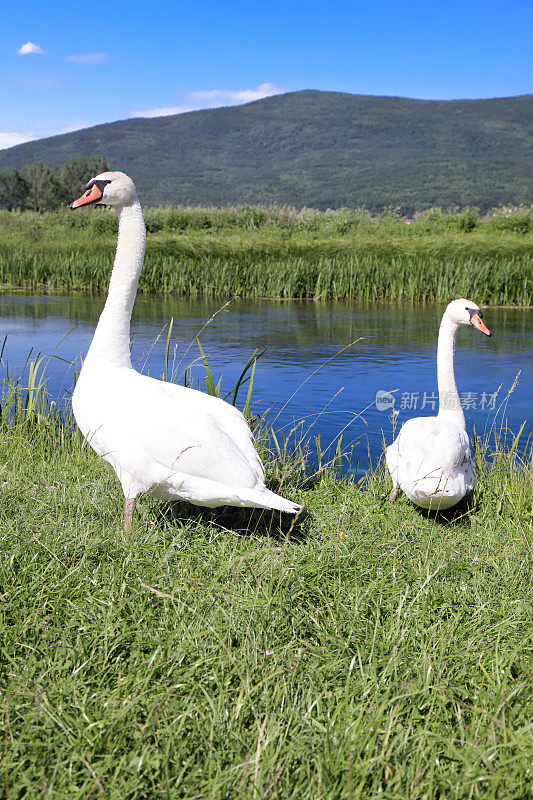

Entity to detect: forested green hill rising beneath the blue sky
[0,91,533,212]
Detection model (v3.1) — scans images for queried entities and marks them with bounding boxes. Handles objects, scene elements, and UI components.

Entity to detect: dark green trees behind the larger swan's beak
[0,155,109,214]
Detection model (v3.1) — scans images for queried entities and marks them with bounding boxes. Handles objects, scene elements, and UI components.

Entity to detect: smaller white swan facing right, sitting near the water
[386,300,491,510]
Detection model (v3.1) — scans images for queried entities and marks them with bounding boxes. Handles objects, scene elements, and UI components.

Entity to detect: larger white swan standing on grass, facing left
[70,172,301,531]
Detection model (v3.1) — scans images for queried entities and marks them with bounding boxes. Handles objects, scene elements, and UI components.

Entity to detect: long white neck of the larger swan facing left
[87,198,146,367]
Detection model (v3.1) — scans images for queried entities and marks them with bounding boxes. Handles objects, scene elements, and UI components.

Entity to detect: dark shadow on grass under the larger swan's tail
[155,500,310,543]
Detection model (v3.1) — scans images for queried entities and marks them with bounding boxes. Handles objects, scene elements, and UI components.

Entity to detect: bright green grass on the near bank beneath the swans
[0,381,533,800]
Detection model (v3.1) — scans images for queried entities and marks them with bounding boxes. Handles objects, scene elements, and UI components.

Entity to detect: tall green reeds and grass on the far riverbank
[0,207,533,305]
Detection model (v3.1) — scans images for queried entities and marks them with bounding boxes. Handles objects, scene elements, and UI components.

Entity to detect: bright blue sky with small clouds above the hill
[0,0,533,148]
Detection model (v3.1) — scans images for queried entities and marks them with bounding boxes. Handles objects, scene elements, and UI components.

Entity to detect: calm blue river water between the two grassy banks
[0,295,533,468]
